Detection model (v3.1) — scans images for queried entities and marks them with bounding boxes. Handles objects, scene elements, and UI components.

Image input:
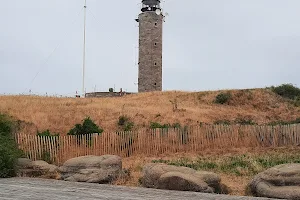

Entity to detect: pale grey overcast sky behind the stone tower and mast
[0,0,300,95]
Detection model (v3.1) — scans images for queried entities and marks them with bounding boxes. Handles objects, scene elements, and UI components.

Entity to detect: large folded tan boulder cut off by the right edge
[249,164,300,200]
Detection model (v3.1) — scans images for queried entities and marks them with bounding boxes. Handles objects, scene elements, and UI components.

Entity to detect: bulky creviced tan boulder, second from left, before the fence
[59,155,122,183]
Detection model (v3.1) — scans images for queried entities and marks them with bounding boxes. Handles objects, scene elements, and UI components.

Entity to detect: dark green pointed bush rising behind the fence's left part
[68,117,103,135]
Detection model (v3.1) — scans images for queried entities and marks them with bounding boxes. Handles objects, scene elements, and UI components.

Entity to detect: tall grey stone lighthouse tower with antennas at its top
[136,0,164,92]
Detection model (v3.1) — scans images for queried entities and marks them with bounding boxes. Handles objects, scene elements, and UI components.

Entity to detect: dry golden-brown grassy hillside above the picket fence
[0,89,300,135]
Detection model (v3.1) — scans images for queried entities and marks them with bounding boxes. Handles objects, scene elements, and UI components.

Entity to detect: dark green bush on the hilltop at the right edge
[272,84,300,100]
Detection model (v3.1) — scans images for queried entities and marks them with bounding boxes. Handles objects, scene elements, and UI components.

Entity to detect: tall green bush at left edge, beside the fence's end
[0,114,22,178]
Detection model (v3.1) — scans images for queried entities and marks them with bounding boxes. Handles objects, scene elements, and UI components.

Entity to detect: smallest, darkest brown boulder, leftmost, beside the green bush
[17,158,58,178]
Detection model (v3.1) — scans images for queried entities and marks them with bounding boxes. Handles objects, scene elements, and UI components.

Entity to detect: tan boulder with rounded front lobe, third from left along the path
[141,163,226,193]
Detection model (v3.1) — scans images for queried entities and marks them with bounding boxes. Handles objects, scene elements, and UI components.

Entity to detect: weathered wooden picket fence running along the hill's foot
[16,124,300,165]
